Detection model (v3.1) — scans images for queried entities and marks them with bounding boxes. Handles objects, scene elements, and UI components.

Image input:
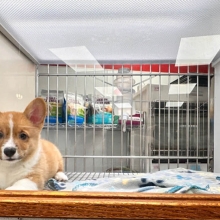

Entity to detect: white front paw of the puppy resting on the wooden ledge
[6,178,38,190]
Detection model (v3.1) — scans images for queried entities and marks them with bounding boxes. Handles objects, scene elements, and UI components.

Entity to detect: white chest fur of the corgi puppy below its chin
[0,146,41,189]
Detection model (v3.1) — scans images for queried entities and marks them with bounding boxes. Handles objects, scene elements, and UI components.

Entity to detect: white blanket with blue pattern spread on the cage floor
[46,168,220,194]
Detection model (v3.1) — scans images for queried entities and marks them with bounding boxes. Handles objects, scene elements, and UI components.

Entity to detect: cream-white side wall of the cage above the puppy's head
[0,32,35,111]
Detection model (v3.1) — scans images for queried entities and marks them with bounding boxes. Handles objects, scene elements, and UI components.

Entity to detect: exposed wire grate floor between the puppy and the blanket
[66,172,136,182]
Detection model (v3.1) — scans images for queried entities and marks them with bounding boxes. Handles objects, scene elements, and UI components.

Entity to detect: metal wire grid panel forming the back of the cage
[36,64,214,173]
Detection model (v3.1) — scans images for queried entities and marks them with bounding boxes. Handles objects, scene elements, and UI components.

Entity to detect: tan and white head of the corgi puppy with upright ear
[0,98,46,163]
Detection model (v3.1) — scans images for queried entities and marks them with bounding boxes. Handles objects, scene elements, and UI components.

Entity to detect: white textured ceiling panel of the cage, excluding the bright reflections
[0,0,220,64]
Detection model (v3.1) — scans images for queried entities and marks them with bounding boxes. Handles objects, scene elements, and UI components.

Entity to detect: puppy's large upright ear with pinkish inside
[24,98,46,126]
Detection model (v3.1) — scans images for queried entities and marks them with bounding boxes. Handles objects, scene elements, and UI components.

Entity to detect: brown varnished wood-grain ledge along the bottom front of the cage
[0,191,220,219]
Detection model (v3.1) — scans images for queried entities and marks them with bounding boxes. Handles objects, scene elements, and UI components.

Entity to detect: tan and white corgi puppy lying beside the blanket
[0,98,67,190]
